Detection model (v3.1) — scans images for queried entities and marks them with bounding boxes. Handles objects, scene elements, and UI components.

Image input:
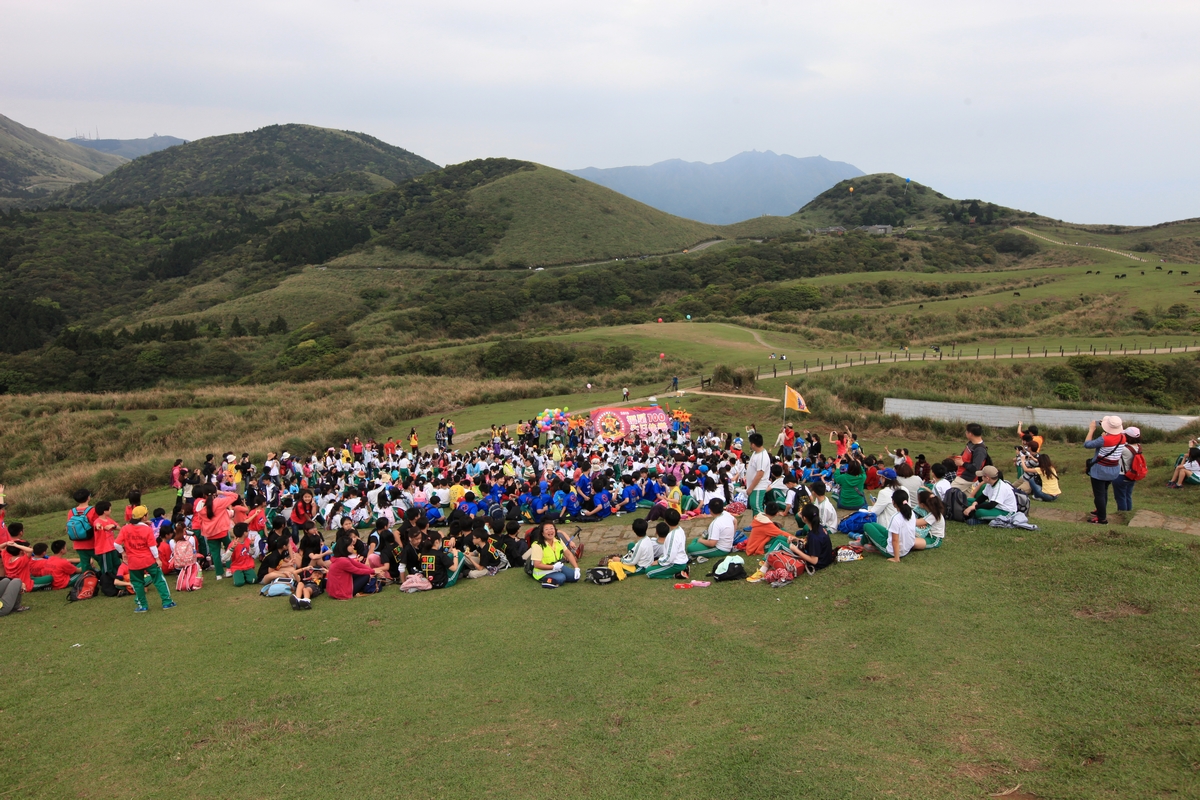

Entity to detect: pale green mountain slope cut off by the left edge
[0,115,127,199]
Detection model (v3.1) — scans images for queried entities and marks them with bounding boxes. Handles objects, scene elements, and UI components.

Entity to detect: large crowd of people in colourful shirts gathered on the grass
[0,417,1176,615]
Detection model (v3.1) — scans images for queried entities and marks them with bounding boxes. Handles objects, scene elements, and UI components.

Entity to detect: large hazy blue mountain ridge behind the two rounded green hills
[566,150,863,224]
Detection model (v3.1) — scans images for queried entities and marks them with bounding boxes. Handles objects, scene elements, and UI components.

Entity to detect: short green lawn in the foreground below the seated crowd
[0,515,1200,799]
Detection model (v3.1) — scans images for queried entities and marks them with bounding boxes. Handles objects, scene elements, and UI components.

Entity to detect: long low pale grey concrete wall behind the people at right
[883,397,1200,431]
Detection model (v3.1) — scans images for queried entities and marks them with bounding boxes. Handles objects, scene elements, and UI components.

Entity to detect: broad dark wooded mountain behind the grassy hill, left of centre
[62,125,438,205]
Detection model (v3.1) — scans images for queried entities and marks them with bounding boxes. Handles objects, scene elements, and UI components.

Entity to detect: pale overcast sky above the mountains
[0,0,1200,224]
